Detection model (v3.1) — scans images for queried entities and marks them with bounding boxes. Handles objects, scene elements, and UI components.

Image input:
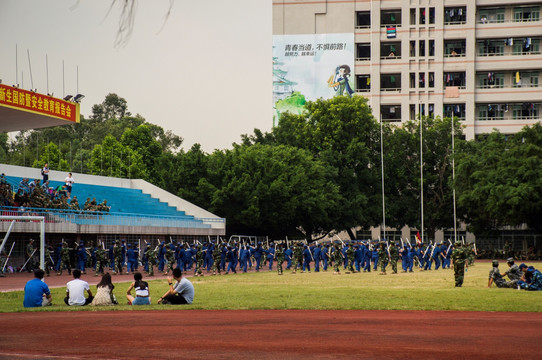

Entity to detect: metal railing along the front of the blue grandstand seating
[0,206,225,228]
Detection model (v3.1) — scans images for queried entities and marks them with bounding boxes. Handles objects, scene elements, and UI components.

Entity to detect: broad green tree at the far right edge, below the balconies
[457,124,542,236]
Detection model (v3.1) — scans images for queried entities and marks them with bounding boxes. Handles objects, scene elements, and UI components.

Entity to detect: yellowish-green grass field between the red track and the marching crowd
[0,262,542,312]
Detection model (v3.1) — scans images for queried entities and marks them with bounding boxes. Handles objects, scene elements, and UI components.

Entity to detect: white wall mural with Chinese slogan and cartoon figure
[273,33,354,126]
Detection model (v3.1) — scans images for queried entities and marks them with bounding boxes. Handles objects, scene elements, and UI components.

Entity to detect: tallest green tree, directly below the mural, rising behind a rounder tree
[251,96,382,239]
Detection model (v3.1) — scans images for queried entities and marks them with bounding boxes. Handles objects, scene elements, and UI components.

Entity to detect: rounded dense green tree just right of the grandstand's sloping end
[207,145,340,240]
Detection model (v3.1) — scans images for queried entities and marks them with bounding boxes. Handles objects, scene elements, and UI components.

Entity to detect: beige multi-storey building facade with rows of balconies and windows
[273,0,542,139]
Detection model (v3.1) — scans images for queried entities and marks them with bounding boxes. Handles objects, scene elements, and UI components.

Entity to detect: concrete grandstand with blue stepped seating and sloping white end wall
[0,164,226,264]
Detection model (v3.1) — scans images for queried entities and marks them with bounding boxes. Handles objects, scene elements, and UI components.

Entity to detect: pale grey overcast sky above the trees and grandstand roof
[0,0,272,153]
